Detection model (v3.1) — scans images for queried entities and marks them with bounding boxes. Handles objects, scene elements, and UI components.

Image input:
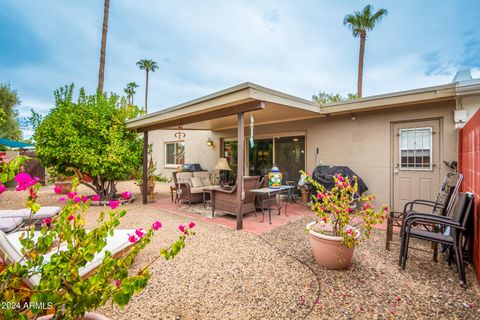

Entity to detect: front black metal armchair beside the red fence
[399,192,474,285]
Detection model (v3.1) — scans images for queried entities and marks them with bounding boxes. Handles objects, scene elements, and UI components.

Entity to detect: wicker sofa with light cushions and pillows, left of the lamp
[172,171,217,206]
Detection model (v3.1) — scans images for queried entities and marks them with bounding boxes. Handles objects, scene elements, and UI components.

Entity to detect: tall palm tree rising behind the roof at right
[343,5,388,98]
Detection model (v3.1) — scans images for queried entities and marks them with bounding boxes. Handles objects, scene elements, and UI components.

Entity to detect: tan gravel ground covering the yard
[0,182,480,319]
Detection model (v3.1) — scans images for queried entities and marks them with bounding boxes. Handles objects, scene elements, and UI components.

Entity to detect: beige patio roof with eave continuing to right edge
[127,79,480,132]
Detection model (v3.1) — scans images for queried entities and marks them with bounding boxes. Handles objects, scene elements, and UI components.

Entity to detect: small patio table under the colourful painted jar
[251,185,295,224]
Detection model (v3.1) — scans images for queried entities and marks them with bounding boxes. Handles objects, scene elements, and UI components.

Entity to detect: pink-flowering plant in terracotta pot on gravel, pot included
[302,172,388,270]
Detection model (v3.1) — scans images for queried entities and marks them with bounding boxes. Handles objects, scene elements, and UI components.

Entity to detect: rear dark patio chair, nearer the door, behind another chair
[385,173,463,252]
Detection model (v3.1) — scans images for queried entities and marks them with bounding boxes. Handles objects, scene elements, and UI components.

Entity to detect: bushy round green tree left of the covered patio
[34,84,142,200]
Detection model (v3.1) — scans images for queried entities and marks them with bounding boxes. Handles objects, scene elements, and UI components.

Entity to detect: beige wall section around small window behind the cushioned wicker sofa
[148,130,220,178]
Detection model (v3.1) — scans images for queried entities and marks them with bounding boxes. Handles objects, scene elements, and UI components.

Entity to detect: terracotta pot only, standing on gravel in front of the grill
[307,221,360,270]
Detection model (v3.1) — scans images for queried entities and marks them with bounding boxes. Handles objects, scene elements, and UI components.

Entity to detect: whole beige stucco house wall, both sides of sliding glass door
[149,100,457,208]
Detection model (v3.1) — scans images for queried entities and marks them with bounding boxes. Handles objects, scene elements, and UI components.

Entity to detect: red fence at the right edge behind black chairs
[458,110,480,281]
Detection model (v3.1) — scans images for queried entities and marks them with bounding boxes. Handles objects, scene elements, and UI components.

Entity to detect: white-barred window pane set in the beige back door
[400,128,433,170]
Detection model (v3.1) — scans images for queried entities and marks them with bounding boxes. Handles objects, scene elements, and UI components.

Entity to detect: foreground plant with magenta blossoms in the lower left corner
[0,164,195,320]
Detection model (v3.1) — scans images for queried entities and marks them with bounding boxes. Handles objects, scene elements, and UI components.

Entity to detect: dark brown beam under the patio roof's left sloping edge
[137,101,265,132]
